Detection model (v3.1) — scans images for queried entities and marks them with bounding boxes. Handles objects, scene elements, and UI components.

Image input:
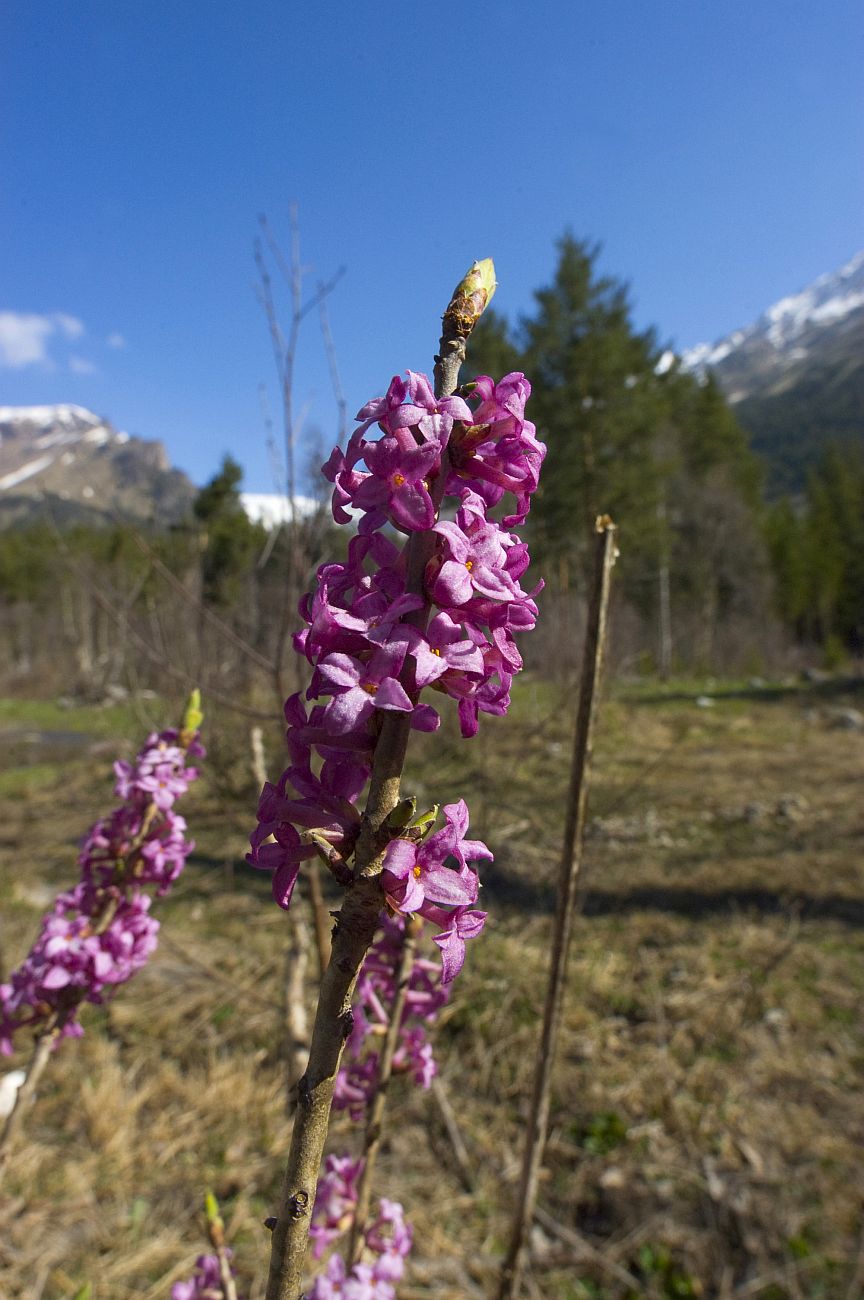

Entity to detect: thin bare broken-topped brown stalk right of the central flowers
[498,515,617,1300]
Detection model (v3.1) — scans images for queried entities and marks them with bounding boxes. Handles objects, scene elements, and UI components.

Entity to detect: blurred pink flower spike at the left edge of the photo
[0,715,204,1054]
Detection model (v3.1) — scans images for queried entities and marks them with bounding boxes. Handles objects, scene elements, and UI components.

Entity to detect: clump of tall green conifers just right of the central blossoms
[472,234,767,668]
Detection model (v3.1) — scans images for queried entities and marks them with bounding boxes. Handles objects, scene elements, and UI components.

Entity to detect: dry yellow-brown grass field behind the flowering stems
[0,680,864,1300]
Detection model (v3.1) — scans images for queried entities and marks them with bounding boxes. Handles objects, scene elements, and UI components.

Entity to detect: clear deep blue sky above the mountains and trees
[0,0,864,491]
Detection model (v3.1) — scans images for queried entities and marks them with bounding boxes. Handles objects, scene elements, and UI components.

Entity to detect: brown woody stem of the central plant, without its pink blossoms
[266,258,485,1300]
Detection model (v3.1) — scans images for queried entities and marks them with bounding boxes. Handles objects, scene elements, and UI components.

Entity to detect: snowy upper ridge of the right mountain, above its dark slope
[681,251,864,403]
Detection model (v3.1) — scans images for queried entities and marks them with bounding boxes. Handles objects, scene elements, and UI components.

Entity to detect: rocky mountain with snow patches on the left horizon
[0,406,195,524]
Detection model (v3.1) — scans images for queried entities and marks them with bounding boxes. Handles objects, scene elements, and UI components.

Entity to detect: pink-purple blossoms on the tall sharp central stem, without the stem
[249,371,546,980]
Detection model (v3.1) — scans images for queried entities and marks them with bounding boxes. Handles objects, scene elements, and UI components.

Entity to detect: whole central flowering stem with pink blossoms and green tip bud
[249,260,546,1300]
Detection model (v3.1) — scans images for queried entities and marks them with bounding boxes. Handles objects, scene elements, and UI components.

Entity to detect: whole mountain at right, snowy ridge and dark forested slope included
[682,252,864,493]
